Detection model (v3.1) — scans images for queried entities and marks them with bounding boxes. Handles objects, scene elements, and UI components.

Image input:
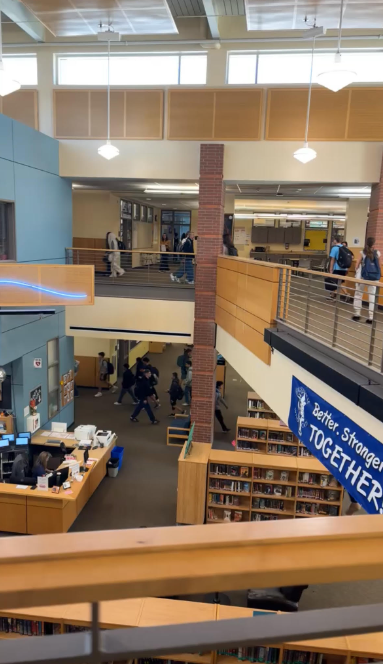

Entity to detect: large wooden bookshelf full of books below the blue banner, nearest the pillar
[206,450,343,524]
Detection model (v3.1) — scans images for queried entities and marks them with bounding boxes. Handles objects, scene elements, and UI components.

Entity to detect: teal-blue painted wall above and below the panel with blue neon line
[0,114,74,431]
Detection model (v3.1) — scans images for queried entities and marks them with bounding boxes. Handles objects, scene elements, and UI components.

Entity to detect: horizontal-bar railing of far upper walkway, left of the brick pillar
[65,247,195,302]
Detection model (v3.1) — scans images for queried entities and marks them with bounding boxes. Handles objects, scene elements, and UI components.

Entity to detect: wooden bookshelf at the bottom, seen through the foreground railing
[0,597,383,664]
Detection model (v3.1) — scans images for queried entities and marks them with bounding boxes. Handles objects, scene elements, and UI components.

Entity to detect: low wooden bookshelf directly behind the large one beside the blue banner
[236,418,313,458]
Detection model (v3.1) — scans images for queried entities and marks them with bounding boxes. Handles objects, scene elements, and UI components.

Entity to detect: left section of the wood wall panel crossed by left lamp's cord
[53,90,90,138]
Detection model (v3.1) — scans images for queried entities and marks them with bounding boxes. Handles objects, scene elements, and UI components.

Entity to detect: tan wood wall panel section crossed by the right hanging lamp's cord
[265,88,350,141]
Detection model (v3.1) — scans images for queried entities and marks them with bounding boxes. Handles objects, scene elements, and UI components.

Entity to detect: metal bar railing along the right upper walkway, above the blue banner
[273,265,383,372]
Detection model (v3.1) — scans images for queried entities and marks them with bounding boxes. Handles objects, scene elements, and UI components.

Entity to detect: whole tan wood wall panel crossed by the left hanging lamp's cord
[53,90,164,140]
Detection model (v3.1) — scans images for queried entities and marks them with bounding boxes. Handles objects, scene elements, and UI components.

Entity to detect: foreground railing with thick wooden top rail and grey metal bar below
[0,516,383,664]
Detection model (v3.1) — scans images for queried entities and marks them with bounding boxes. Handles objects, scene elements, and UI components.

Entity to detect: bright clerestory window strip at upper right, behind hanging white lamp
[228,51,383,85]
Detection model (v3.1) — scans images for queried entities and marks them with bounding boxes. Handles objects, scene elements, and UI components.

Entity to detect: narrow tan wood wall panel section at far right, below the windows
[347,88,383,141]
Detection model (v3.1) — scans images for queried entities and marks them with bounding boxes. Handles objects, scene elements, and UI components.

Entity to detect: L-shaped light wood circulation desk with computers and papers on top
[0,431,117,535]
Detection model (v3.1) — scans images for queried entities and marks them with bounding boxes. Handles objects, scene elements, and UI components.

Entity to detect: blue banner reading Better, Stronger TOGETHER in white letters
[288,376,383,514]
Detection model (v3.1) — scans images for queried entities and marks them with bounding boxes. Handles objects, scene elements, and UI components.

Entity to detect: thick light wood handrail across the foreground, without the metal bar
[0,515,383,609]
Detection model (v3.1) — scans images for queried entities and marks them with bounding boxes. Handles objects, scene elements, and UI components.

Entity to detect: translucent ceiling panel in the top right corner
[245,0,383,30]
